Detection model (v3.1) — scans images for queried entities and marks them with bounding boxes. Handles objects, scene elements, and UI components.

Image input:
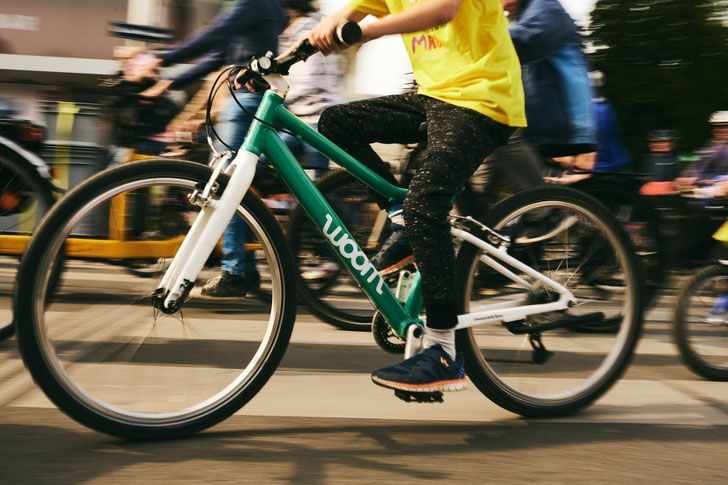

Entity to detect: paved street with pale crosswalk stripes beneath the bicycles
[0,262,728,483]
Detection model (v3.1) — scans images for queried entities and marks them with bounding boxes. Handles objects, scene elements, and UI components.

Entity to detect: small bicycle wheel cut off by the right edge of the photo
[672,264,728,381]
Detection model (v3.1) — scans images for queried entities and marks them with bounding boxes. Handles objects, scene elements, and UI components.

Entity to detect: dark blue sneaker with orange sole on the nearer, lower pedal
[372,345,467,392]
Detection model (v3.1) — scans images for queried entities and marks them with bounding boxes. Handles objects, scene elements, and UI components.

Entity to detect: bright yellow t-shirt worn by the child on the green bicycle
[349,0,526,127]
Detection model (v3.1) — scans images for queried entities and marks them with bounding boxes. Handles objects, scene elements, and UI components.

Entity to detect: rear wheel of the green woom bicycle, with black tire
[457,187,641,417]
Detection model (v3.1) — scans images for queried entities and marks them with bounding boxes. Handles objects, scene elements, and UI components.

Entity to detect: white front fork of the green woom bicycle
[155,150,259,309]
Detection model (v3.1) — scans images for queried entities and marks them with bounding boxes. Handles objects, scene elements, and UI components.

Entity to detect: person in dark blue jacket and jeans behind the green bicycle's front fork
[136,0,288,299]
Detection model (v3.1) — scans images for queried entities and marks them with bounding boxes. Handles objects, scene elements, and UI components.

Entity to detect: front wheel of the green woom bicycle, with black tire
[14,160,296,439]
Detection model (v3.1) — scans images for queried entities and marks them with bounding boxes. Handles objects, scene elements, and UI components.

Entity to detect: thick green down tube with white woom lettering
[264,134,417,335]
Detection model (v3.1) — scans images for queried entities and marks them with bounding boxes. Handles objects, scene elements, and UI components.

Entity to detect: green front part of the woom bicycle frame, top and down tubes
[241,91,422,337]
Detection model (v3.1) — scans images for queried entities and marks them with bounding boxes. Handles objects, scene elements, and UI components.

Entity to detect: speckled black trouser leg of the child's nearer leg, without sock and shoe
[404,98,512,352]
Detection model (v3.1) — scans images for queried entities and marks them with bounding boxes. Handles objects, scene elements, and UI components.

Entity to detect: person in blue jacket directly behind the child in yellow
[464,0,596,217]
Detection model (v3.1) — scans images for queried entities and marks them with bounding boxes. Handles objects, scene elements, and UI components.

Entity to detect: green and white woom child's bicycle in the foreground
[14,24,641,439]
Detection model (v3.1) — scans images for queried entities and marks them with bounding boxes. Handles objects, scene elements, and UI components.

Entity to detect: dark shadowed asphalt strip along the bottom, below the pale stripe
[0,406,728,484]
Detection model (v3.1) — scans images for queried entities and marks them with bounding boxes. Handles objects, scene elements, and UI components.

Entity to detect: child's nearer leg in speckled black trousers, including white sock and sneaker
[372,97,513,390]
